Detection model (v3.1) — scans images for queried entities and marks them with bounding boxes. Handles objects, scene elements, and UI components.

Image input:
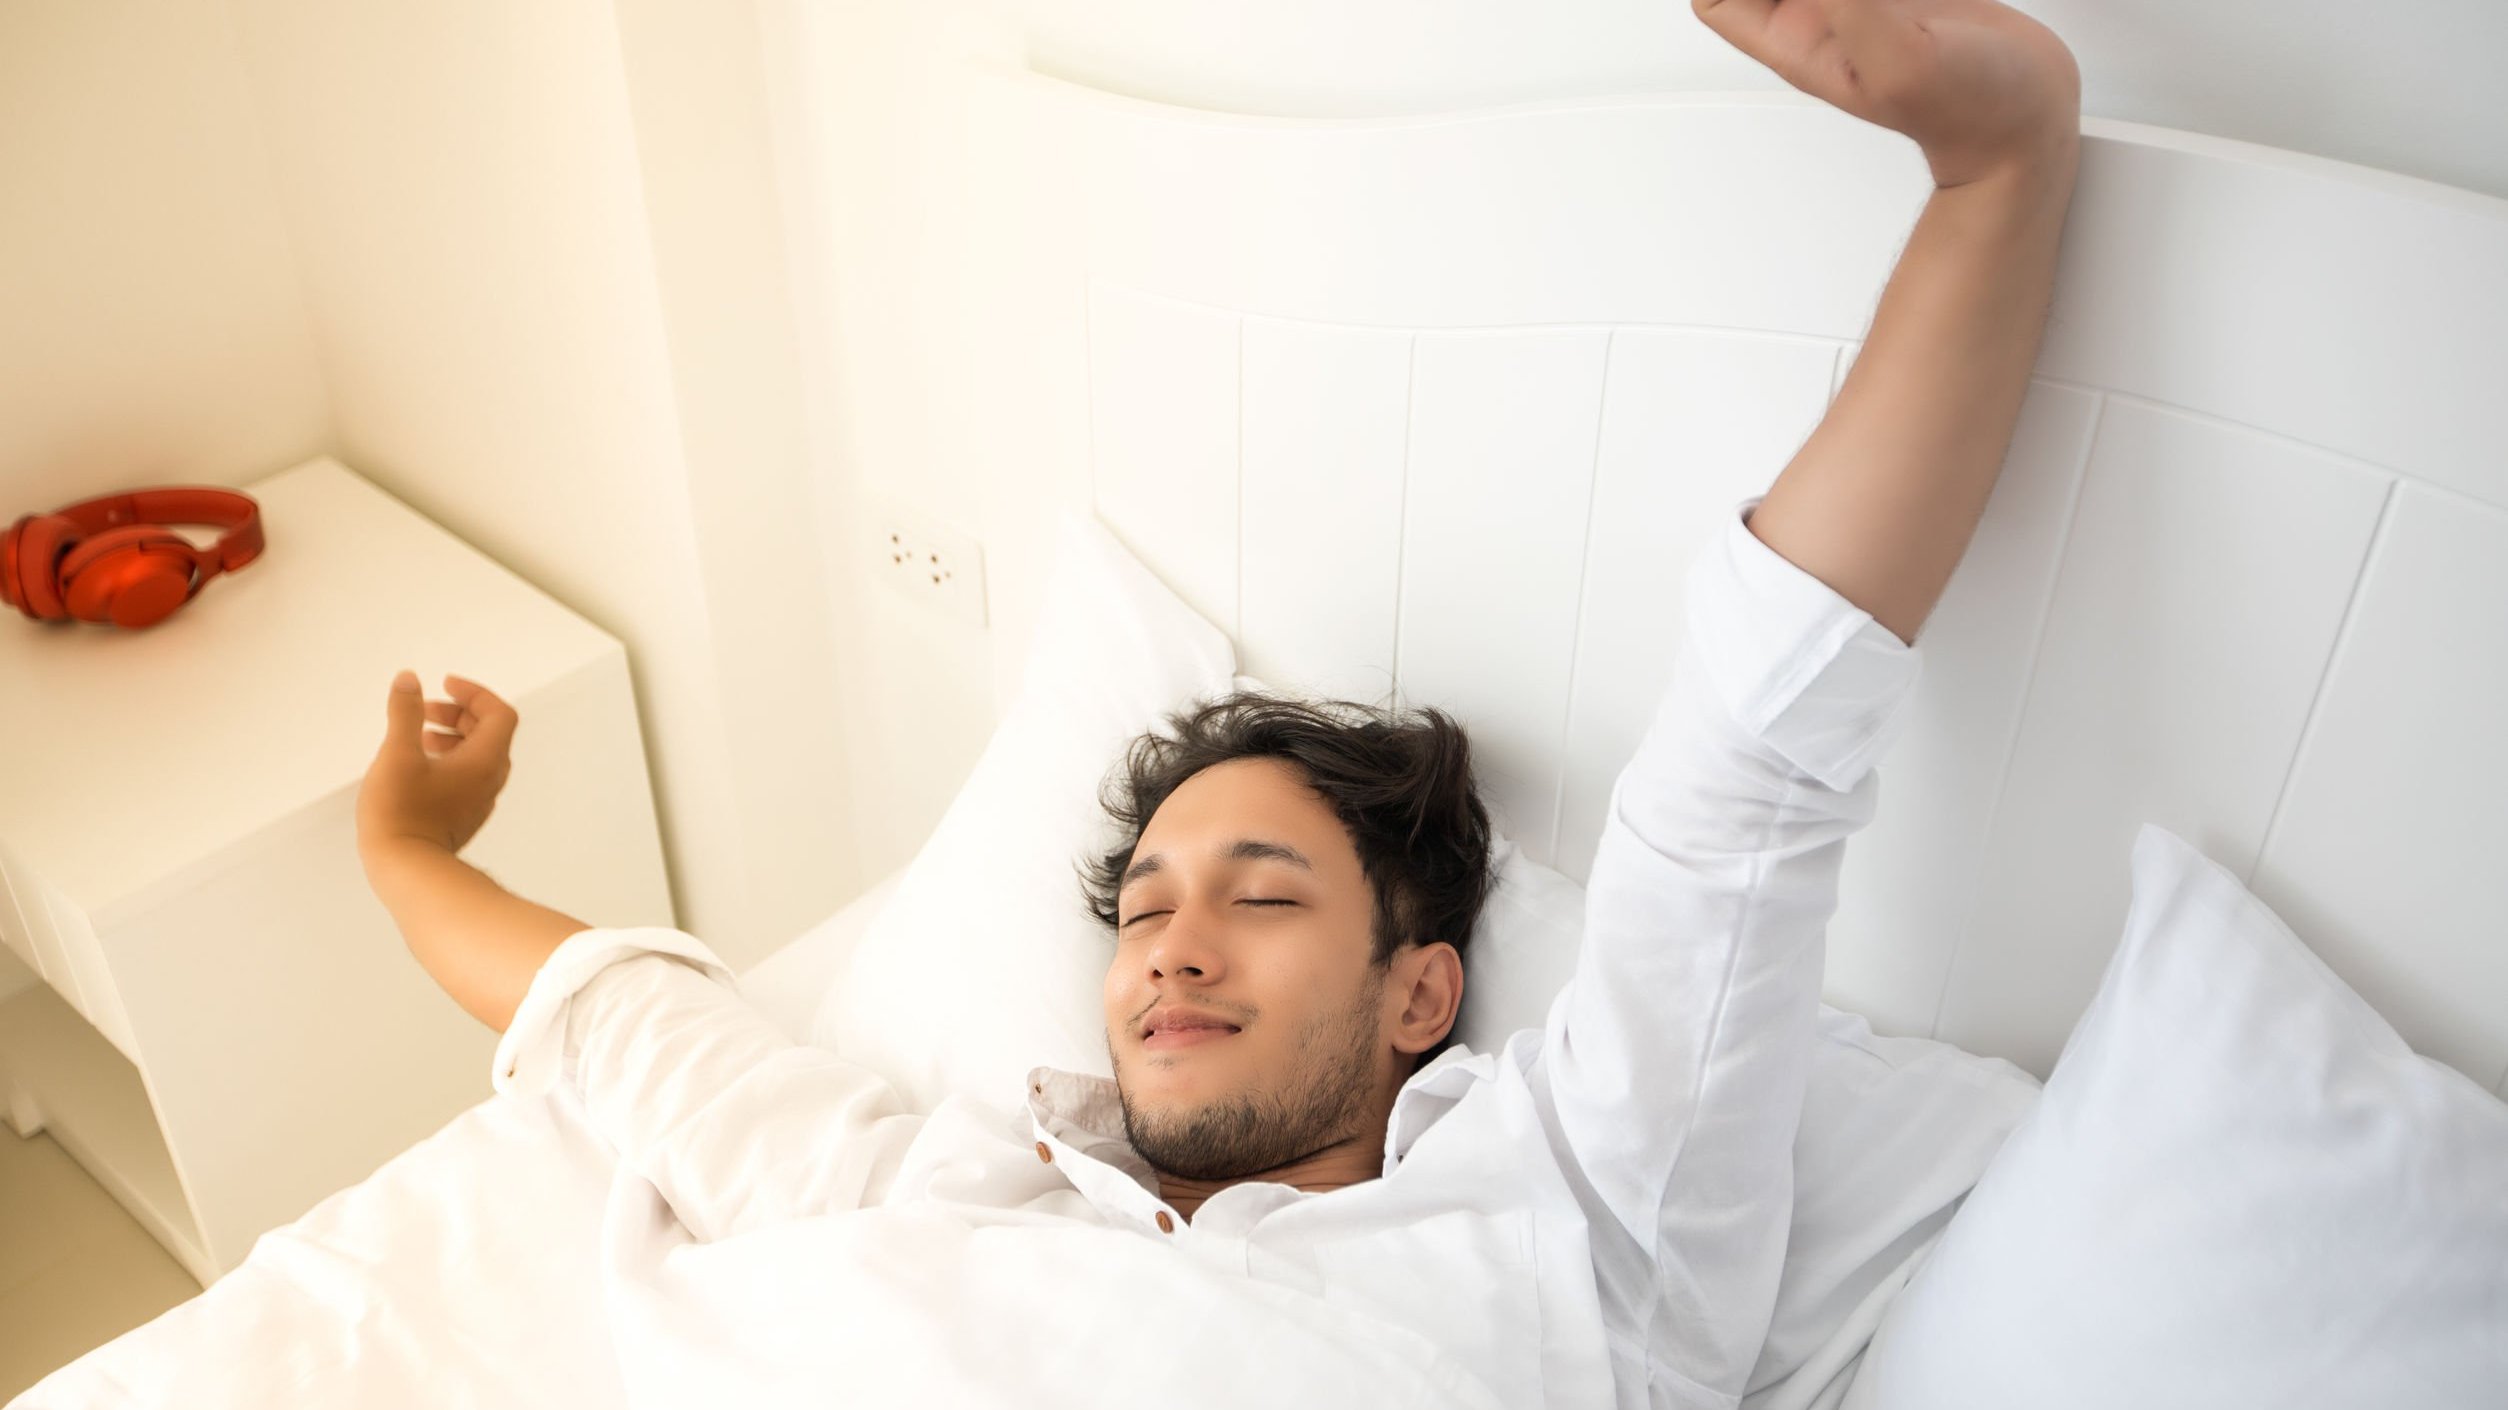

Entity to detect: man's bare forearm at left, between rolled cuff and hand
[359,838,592,1034]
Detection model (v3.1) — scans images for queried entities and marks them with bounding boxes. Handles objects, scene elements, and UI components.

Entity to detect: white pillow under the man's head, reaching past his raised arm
[813,517,2036,1410]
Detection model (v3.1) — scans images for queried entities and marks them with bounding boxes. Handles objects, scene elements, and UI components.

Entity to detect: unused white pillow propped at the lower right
[1846,825,2508,1410]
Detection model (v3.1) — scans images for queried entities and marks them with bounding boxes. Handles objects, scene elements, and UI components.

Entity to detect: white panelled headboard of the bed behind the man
[913,60,2508,1089]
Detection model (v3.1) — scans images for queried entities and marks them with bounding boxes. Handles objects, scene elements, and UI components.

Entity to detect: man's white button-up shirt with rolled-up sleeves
[497,489,1919,1407]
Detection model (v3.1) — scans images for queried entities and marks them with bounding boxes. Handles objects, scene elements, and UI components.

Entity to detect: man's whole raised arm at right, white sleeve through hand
[1530,0,2079,1407]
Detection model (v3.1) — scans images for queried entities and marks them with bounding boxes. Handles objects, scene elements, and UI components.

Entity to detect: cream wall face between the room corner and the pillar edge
[233,0,747,956]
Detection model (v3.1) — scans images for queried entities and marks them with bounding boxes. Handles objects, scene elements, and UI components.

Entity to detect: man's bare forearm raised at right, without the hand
[1751,138,2079,642]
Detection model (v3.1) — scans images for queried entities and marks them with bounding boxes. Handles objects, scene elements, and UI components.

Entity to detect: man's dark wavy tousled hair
[1081,690,1490,1066]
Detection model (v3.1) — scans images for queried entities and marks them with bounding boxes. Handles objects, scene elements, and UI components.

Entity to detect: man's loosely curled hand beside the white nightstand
[356,670,522,853]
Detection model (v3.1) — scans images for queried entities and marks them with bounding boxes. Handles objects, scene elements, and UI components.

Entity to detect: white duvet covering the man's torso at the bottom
[15,1068,1490,1410]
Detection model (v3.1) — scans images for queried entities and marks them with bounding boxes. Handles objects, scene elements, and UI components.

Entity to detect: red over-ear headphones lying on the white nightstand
[0,484,261,630]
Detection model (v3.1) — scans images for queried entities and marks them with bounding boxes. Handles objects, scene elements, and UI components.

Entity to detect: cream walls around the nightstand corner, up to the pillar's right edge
[0,0,863,966]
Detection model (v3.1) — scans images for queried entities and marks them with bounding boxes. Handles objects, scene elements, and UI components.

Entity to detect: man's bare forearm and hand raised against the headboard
[1693,0,2082,642]
